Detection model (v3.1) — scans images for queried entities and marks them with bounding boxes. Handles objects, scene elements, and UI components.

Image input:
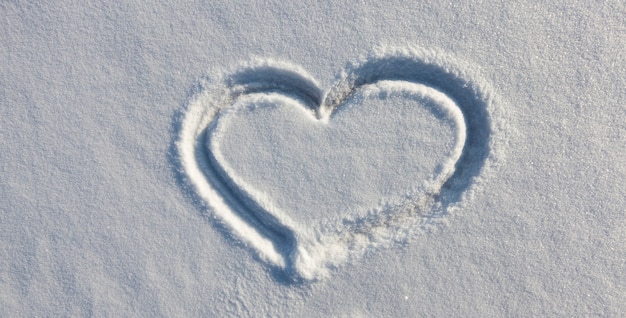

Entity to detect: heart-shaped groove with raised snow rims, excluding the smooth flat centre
[177,48,497,281]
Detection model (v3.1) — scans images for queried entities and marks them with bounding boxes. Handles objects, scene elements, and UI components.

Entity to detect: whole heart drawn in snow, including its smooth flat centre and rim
[177,46,498,280]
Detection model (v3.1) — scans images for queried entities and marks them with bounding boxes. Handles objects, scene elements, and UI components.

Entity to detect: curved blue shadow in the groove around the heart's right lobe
[332,56,492,207]
